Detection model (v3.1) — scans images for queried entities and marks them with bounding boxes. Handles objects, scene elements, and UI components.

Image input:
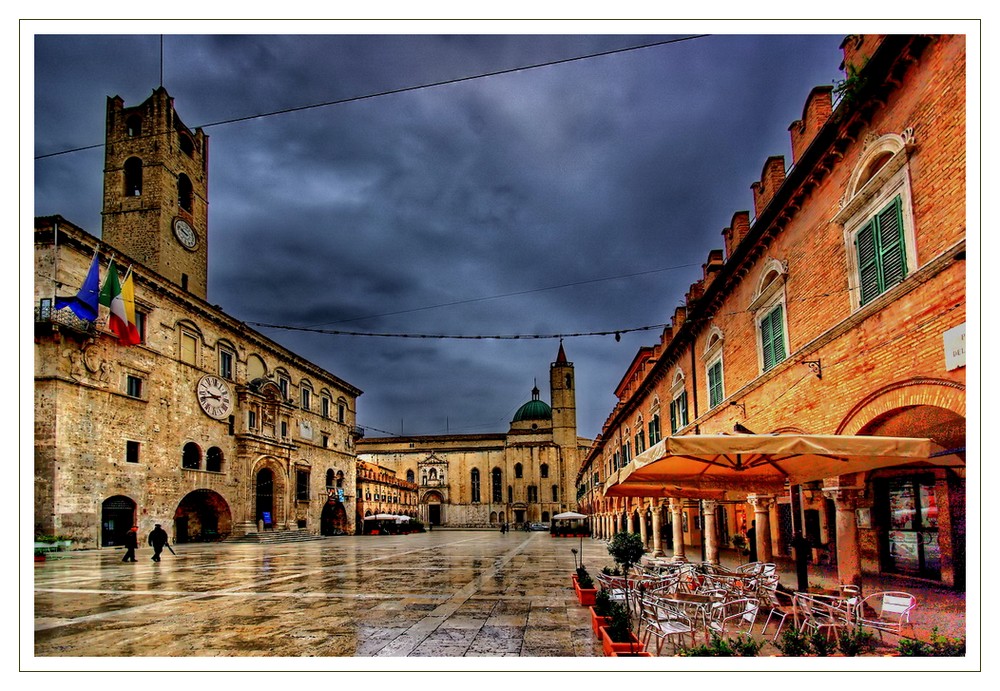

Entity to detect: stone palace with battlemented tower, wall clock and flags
[34,87,361,547]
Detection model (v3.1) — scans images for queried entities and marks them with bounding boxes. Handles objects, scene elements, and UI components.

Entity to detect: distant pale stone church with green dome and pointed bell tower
[357,344,591,529]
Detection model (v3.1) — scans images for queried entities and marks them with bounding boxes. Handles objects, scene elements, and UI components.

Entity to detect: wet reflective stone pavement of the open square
[34,530,608,657]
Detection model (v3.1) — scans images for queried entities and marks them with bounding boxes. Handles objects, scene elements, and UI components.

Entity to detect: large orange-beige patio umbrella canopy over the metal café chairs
[605,434,965,496]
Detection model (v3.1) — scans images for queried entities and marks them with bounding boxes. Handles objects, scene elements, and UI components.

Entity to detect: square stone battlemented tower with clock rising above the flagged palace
[102,86,208,299]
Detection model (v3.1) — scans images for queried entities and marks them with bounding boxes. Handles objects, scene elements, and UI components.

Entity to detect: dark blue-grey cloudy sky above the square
[33,22,846,444]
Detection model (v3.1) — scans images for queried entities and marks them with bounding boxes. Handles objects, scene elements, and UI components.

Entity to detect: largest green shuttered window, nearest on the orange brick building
[854,196,906,305]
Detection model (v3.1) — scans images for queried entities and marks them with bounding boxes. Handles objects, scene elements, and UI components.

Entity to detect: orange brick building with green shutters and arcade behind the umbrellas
[577,35,966,587]
